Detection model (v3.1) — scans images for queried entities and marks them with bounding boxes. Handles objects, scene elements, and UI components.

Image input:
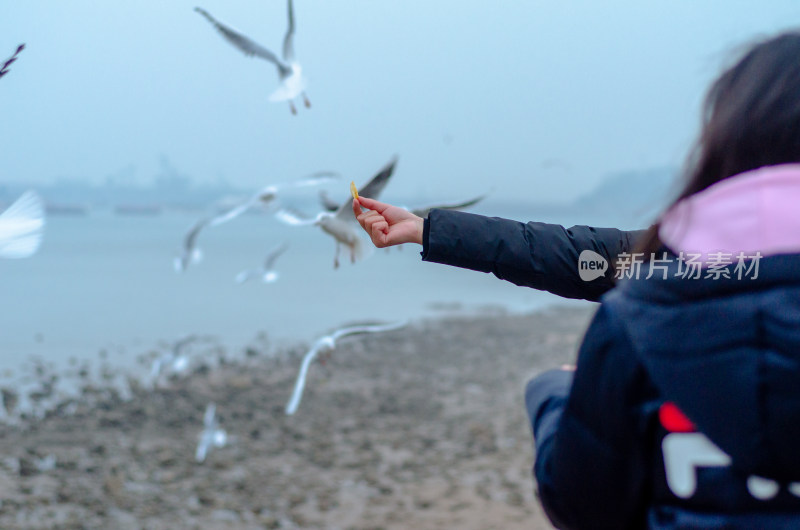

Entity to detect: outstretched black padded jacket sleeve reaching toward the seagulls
[422,210,643,301]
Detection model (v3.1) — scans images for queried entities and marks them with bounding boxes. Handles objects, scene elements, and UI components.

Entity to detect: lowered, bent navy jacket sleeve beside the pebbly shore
[525,306,650,530]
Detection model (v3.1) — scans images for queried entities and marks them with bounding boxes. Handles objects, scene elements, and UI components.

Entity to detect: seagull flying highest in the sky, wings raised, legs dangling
[194,0,311,114]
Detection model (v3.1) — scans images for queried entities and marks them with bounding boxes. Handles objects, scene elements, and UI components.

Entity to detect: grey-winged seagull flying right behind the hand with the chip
[275,157,397,268]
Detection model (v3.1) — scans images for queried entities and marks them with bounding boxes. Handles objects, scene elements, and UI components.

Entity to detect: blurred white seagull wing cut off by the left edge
[0,190,44,258]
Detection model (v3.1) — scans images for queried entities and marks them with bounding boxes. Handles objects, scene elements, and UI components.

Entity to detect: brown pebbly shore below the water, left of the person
[0,307,593,530]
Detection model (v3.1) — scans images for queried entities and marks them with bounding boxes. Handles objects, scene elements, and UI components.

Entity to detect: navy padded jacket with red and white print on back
[423,206,800,530]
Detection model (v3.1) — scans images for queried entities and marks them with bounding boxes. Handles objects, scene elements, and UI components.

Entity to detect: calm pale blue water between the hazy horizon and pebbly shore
[0,204,592,378]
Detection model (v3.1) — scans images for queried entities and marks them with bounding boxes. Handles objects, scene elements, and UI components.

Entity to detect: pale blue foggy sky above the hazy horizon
[0,0,800,202]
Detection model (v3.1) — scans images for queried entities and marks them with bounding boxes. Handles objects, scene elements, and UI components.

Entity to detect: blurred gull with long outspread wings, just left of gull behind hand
[173,171,339,272]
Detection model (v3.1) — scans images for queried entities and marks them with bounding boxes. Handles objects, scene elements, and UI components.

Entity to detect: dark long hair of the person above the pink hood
[637,30,800,256]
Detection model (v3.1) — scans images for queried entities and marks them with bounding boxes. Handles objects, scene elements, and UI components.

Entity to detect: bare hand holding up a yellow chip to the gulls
[353,196,424,248]
